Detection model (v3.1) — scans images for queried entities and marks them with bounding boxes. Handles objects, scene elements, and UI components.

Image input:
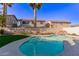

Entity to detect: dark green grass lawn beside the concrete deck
[0,35,29,48]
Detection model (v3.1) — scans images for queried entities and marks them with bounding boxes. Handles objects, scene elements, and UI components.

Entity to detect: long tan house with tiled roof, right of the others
[46,20,71,28]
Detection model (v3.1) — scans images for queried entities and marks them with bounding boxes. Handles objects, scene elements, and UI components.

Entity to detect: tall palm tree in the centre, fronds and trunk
[30,3,42,27]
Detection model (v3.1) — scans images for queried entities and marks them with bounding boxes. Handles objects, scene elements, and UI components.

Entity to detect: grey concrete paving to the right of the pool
[60,40,79,56]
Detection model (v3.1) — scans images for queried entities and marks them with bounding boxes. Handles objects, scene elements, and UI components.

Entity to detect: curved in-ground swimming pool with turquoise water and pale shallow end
[19,35,65,56]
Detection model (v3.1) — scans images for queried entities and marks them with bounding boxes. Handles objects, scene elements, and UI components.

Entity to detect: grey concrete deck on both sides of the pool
[0,38,79,56]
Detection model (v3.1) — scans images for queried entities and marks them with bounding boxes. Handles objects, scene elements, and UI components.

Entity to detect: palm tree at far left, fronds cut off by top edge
[1,3,13,26]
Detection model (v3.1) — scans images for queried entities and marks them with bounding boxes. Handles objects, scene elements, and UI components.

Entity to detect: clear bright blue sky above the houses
[0,3,79,24]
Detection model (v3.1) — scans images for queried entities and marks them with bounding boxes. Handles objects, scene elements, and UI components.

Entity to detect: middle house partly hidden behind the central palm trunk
[19,19,45,27]
